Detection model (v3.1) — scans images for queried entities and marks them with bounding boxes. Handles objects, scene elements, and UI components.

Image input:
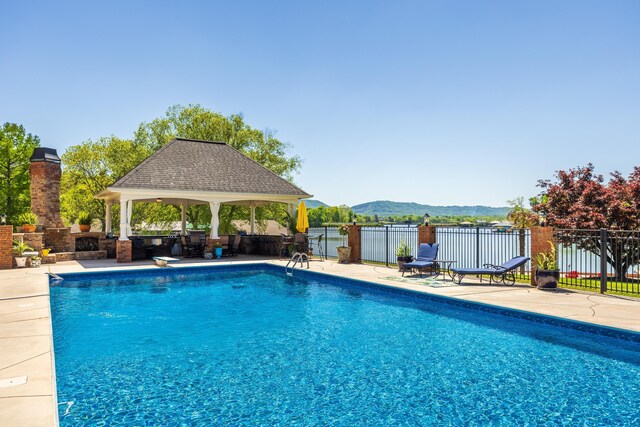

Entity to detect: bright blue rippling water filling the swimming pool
[51,266,640,426]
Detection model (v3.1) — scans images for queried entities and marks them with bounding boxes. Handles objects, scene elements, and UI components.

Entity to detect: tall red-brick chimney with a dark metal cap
[30,147,64,228]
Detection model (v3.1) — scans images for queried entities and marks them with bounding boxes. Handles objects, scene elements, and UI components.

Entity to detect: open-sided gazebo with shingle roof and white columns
[96,138,312,241]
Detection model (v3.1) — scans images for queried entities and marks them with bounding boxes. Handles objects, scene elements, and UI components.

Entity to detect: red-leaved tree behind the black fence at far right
[532,163,640,280]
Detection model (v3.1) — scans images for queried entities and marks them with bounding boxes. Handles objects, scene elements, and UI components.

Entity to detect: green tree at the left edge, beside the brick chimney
[0,123,40,224]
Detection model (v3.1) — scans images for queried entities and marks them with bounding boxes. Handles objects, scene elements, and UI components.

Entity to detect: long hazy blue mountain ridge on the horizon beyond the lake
[350,200,511,217]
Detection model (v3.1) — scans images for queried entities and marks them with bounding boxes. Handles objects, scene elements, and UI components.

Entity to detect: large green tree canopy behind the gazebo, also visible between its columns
[61,105,301,233]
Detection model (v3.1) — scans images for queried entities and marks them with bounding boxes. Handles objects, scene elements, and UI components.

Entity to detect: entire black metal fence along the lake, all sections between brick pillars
[309,225,640,294]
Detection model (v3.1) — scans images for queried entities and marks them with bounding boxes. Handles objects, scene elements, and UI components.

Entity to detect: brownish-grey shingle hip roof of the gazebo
[110,138,310,197]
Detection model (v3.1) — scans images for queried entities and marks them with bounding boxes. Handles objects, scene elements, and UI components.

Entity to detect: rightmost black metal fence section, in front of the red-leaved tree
[554,229,640,294]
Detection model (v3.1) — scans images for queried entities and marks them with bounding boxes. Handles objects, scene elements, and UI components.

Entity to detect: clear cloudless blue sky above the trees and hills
[0,0,640,206]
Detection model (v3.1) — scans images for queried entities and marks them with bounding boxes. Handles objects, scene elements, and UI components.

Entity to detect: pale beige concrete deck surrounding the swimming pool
[0,256,640,427]
